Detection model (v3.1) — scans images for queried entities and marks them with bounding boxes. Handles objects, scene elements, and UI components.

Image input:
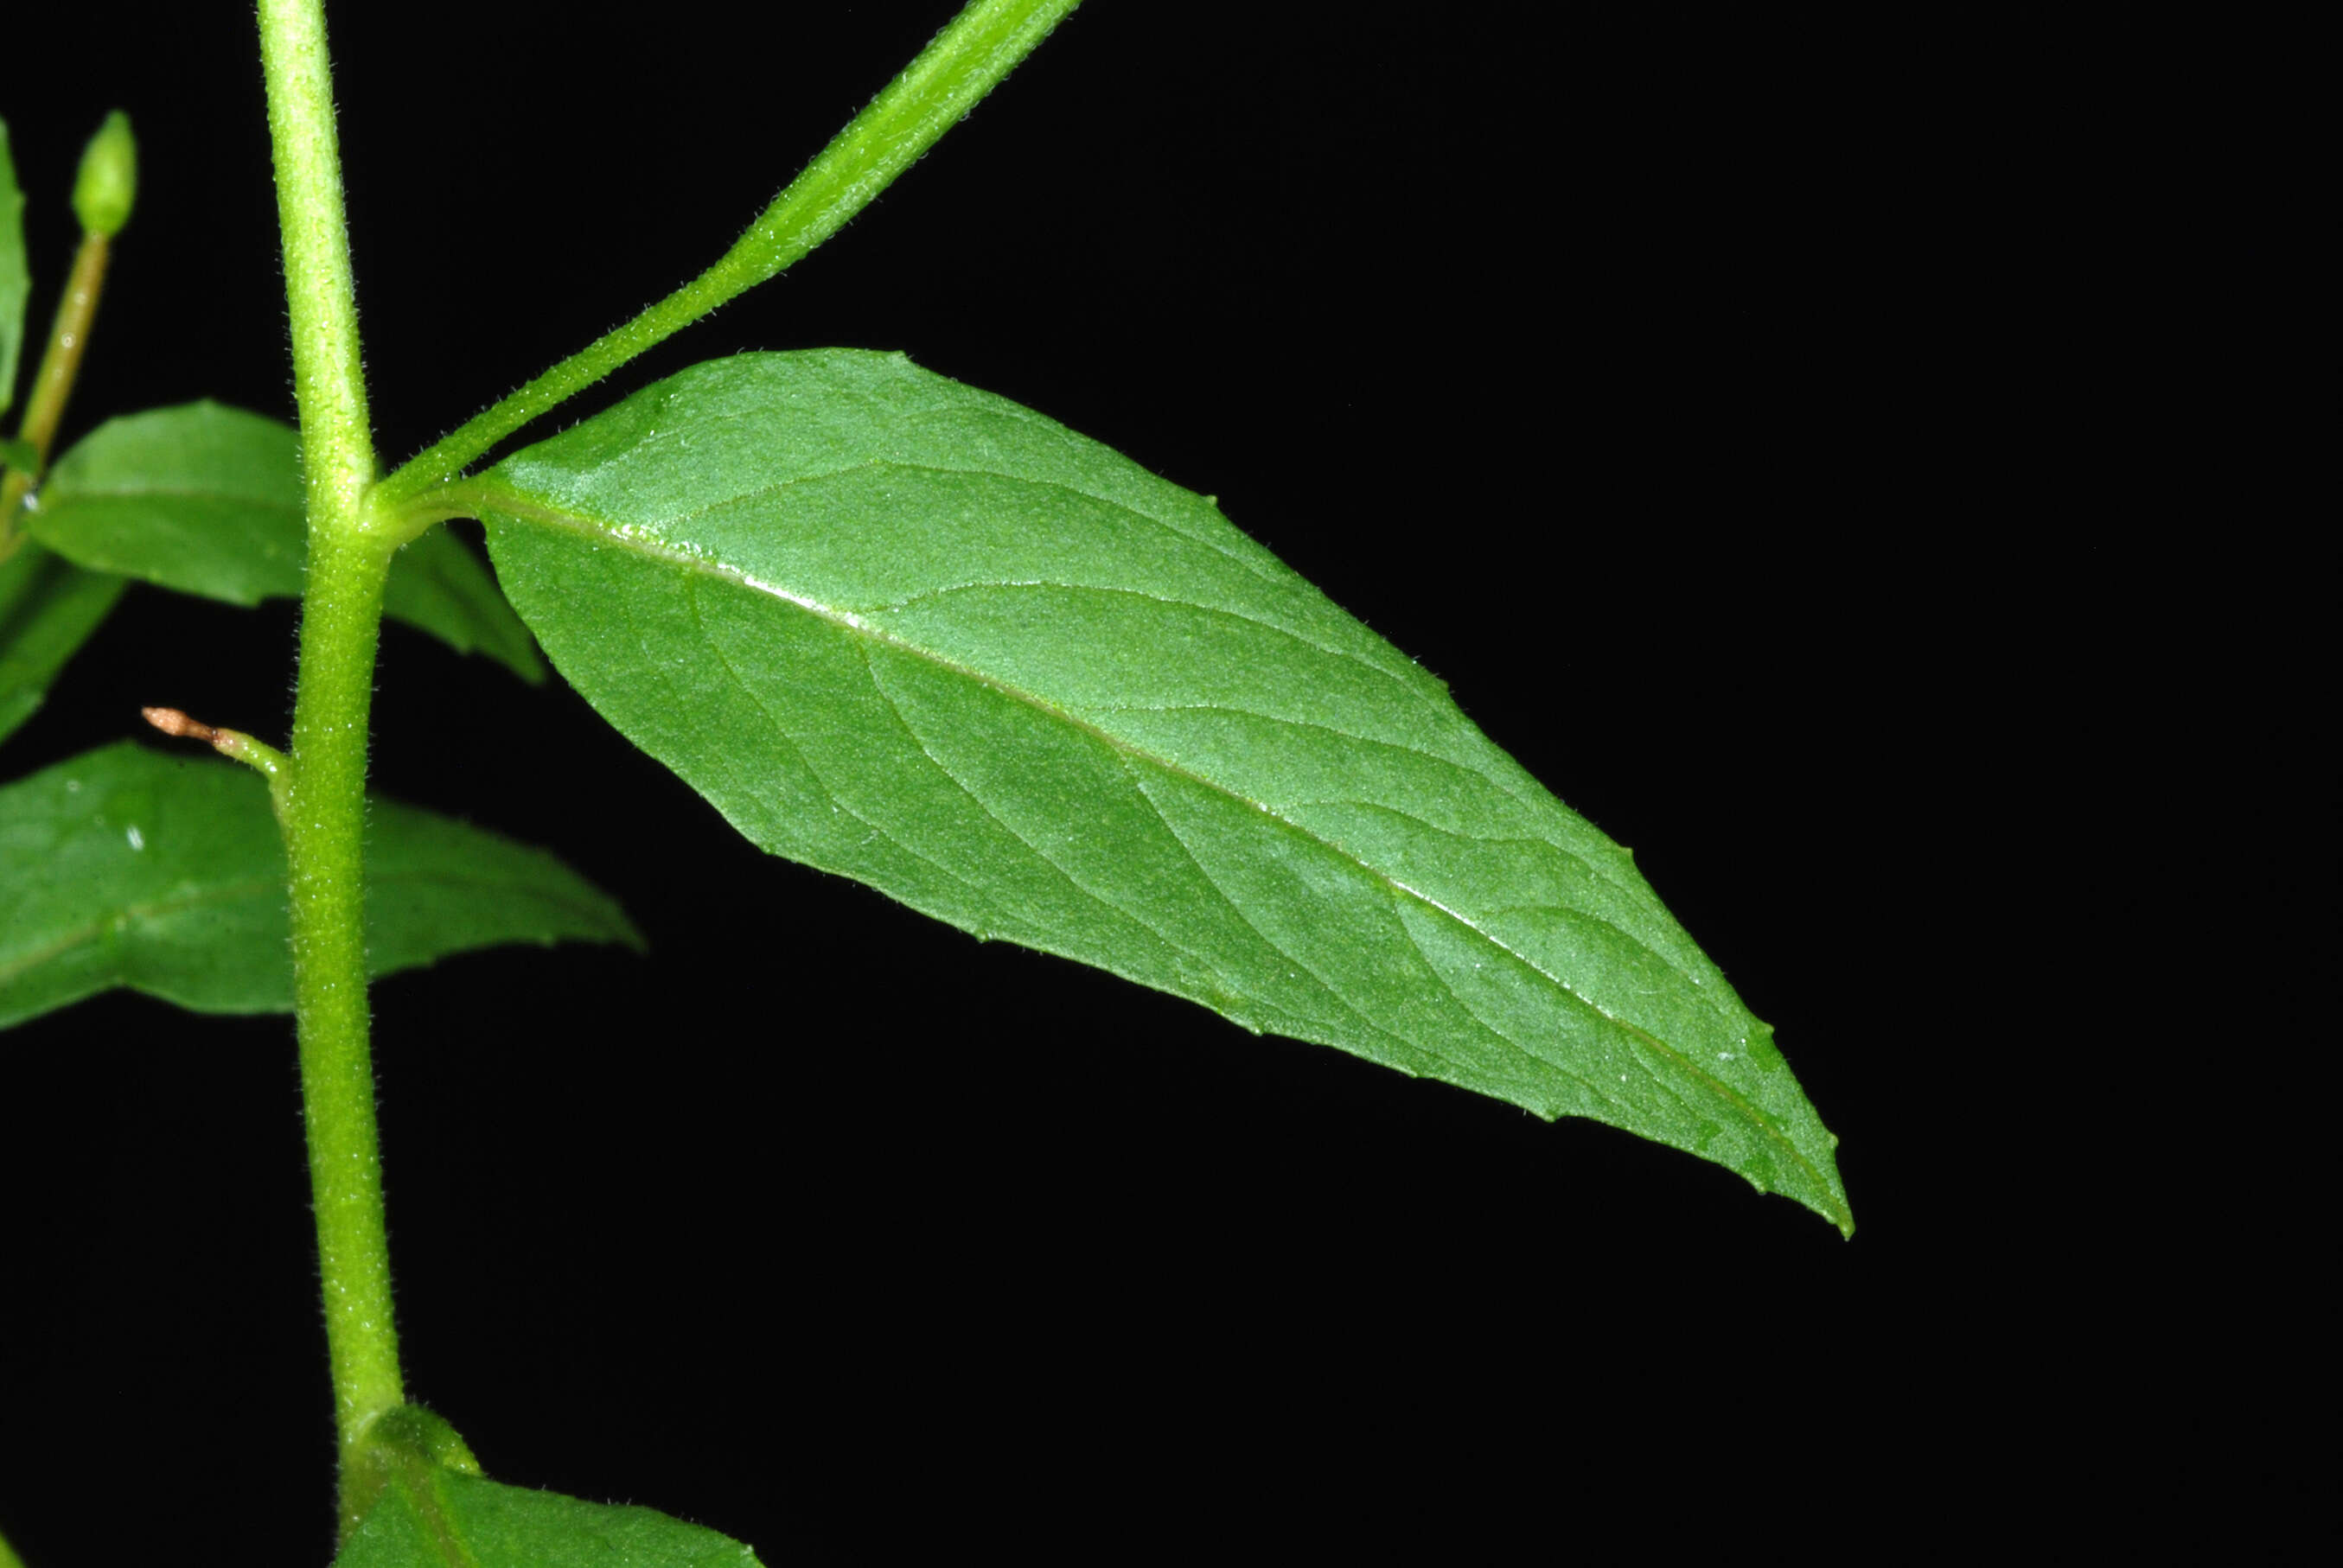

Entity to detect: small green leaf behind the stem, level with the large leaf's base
[33,401,544,682]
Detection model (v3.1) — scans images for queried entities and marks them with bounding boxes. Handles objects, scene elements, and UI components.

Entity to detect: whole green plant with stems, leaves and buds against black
[0,0,1851,1568]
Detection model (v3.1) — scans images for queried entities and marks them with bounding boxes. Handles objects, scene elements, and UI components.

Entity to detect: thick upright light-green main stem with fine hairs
[260,0,405,1535]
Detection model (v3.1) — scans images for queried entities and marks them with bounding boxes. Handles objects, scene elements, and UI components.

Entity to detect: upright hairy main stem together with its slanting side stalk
[252,0,1078,1538]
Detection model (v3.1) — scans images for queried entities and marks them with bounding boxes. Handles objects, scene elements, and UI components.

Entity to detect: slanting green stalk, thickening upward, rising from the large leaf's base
[380,0,1080,508]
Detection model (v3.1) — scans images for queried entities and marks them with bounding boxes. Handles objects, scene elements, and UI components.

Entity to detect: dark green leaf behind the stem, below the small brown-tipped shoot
[0,741,642,1027]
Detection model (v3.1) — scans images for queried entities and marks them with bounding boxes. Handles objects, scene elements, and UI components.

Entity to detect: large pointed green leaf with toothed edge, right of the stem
[478,352,1851,1228]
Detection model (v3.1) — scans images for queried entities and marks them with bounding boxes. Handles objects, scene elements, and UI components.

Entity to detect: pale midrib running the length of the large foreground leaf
[478,475,1837,1207]
